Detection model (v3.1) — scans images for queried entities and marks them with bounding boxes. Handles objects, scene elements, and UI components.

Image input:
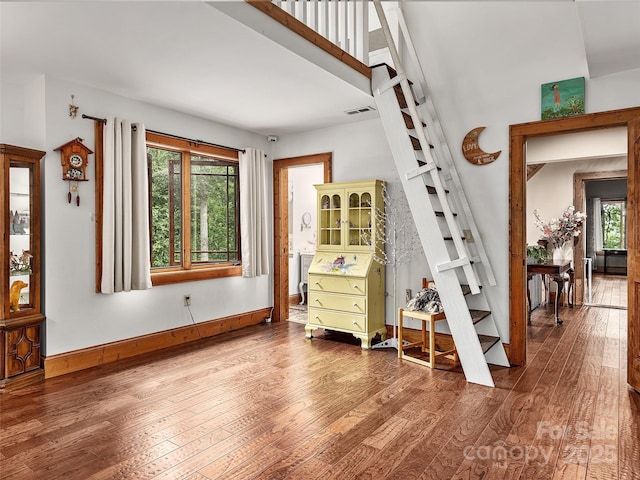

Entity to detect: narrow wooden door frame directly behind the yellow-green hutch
[271,152,332,322]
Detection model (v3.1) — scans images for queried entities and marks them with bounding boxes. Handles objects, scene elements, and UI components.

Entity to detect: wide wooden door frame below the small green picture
[509,108,640,388]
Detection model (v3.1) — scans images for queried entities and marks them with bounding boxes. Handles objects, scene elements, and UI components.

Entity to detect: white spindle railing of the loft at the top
[272,0,369,64]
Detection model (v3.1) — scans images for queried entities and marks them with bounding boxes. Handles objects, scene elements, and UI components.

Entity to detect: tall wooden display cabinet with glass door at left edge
[0,144,46,392]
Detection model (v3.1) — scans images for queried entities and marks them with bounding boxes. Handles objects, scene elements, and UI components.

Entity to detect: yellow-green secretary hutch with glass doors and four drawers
[305,180,387,349]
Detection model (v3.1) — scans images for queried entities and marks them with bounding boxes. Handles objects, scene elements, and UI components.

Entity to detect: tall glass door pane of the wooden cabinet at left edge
[9,166,33,311]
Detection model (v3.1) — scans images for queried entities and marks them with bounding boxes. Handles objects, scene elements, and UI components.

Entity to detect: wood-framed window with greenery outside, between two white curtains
[147,133,241,285]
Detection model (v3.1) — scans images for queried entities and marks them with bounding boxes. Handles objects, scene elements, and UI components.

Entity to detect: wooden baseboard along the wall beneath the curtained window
[44,308,271,378]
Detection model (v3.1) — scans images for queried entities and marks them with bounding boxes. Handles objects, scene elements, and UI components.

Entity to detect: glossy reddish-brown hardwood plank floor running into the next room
[0,307,640,480]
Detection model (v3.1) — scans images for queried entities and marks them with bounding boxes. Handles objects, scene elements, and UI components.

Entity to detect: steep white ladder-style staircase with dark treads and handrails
[372,0,509,387]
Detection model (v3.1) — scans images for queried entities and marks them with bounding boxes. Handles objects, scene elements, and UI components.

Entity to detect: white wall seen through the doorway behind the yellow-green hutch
[288,164,324,295]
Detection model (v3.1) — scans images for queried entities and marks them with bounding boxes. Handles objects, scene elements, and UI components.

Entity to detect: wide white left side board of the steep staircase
[372,68,504,387]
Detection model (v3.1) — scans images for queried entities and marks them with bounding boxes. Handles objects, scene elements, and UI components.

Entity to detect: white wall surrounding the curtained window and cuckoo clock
[2,73,273,355]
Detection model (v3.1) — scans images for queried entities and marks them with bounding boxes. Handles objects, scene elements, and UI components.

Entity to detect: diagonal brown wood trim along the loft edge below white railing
[245,0,371,79]
